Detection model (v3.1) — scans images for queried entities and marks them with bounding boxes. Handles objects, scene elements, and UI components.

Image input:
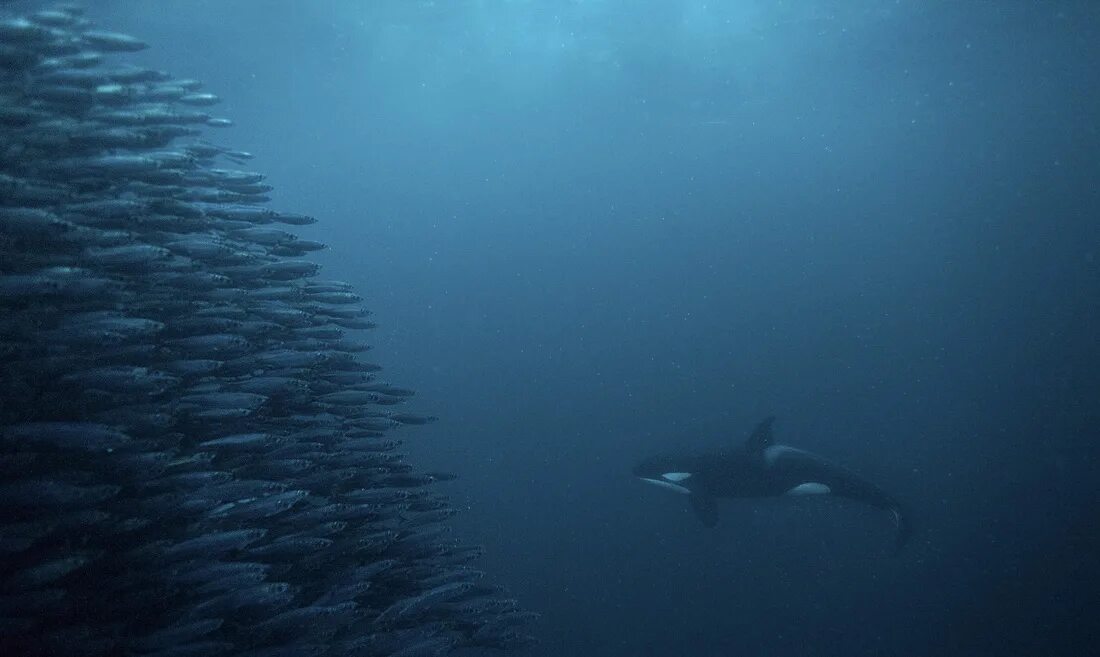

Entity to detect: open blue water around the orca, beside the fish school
[60,0,1100,656]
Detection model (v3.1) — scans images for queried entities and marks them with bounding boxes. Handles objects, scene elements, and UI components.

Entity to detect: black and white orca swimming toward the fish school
[634,417,910,551]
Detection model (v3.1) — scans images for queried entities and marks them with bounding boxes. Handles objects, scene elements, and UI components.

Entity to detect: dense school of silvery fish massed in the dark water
[0,6,535,657]
